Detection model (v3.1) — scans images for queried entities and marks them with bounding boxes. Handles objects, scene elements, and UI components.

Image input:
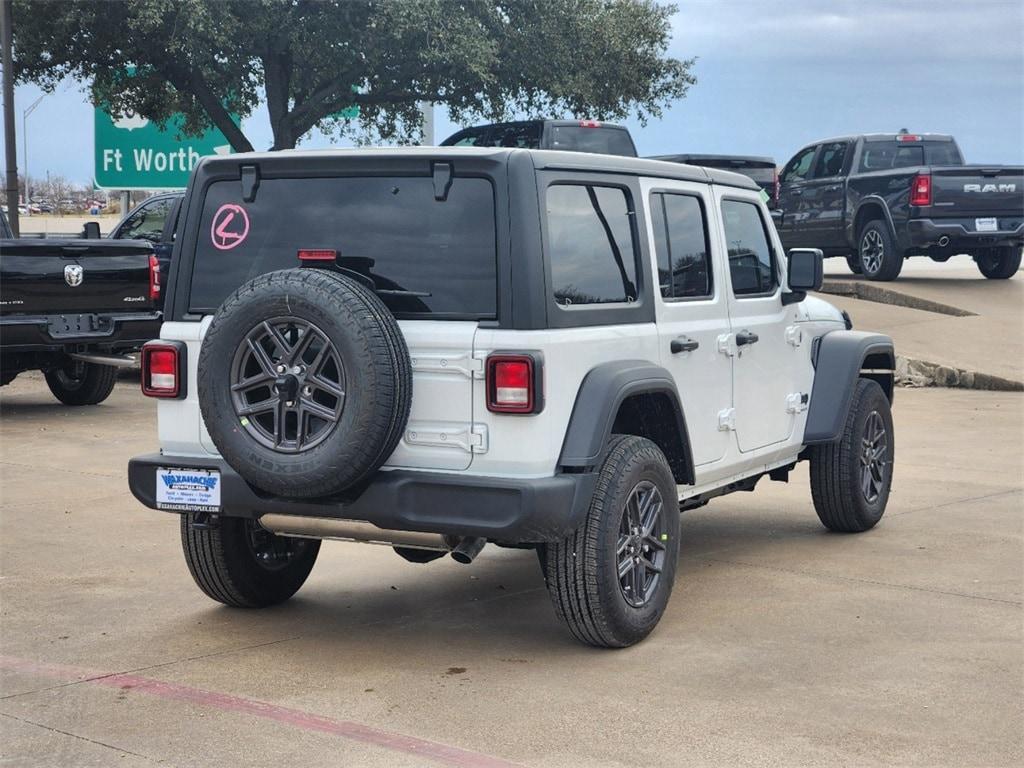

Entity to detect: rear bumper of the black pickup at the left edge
[0,311,163,352]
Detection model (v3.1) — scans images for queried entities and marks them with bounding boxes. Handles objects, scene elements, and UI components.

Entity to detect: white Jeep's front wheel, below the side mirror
[810,379,895,534]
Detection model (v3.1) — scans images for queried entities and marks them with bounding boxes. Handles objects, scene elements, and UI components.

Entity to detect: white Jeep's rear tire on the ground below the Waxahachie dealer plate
[181,512,321,608]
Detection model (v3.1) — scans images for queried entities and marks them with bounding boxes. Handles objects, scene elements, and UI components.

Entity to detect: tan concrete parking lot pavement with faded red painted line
[0,265,1024,766]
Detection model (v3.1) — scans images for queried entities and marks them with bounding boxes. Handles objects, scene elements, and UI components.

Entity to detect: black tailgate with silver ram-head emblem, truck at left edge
[0,239,154,314]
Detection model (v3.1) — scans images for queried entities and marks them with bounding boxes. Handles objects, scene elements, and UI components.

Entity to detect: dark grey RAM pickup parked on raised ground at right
[774,132,1024,281]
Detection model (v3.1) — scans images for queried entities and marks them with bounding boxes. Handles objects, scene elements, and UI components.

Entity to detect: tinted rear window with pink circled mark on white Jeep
[189,177,497,318]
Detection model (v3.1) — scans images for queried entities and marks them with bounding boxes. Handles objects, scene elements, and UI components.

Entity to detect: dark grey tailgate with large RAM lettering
[932,165,1024,217]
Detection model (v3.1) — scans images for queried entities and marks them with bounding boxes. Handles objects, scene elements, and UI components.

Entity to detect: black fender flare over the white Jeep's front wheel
[804,331,896,445]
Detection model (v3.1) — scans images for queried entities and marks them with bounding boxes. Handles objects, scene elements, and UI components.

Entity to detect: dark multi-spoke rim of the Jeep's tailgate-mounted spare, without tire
[230,316,345,454]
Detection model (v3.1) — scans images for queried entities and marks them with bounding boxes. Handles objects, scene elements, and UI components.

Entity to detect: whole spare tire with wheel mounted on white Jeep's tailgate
[198,268,413,498]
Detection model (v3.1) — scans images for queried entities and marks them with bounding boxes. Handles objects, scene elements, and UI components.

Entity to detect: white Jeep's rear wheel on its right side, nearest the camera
[539,435,679,648]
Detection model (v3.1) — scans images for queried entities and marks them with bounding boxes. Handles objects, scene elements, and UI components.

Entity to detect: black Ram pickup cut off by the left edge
[0,214,162,406]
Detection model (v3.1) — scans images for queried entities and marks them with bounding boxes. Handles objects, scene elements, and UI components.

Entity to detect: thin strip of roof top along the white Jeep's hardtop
[196,146,760,189]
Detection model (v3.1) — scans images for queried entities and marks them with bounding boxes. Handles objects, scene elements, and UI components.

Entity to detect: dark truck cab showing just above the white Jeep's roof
[440,120,637,158]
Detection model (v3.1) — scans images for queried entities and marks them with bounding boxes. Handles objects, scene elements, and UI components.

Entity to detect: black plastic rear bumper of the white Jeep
[128,454,597,544]
